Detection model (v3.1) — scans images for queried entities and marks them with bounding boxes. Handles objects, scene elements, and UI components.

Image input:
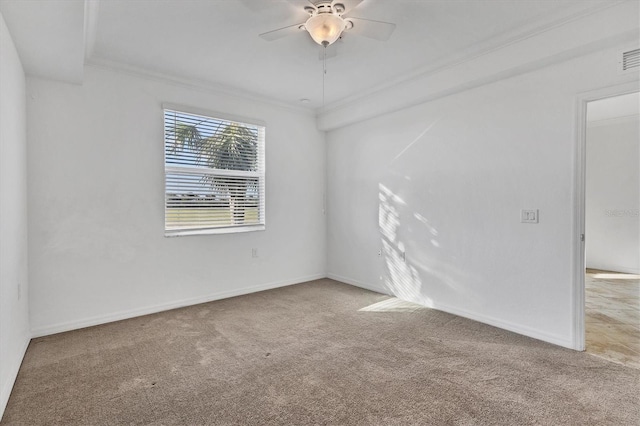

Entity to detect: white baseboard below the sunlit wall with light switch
[327,273,575,349]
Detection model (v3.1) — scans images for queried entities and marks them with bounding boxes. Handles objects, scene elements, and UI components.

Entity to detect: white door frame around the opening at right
[573,81,640,351]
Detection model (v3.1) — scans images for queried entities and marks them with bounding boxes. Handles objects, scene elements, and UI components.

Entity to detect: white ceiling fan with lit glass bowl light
[260,0,396,48]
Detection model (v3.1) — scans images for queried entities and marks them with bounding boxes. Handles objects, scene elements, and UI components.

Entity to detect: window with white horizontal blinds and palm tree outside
[164,108,265,236]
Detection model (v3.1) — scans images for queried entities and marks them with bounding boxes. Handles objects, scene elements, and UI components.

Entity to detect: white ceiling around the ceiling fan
[0,0,614,108]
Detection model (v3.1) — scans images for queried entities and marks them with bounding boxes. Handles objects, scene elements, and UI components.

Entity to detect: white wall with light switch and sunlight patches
[327,48,638,347]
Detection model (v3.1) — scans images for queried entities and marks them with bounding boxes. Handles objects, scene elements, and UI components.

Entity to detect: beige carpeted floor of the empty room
[1,280,640,425]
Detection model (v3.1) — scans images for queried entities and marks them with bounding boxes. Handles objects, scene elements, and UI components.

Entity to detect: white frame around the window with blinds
[161,103,267,237]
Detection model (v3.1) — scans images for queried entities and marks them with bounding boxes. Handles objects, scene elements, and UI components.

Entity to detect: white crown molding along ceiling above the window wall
[85,56,316,117]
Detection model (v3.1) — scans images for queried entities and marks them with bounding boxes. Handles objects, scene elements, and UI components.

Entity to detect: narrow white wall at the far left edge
[0,10,31,418]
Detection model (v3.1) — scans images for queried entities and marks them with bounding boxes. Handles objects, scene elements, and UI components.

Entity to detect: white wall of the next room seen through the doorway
[585,116,640,274]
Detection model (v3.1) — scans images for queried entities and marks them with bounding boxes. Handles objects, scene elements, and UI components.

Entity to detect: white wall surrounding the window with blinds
[27,67,326,335]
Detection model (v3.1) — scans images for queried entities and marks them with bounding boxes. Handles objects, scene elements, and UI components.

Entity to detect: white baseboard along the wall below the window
[31,274,326,338]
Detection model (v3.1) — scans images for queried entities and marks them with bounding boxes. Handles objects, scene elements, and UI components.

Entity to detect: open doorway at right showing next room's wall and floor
[583,92,640,368]
